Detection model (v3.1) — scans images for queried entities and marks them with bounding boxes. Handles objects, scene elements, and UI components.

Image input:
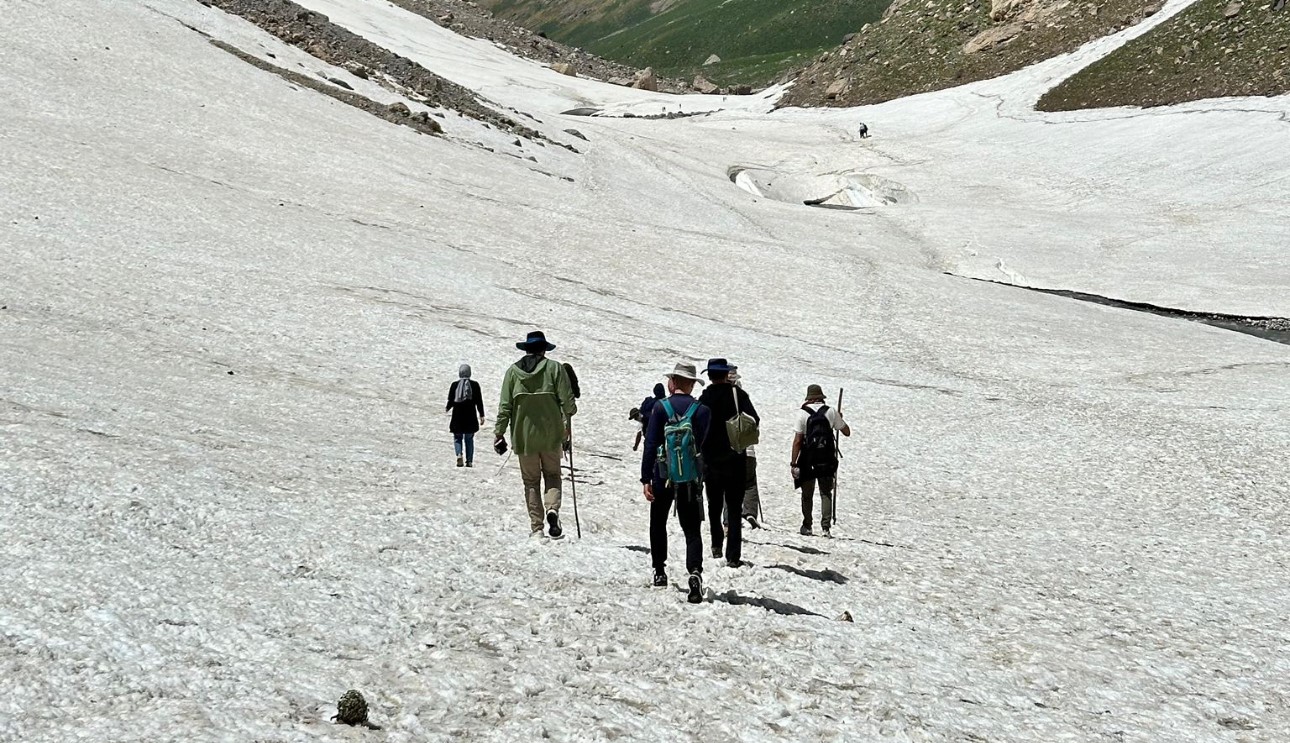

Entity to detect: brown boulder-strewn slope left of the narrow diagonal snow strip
[780,0,1161,106]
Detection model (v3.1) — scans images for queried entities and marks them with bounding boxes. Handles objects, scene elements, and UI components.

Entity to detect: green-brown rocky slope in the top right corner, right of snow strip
[1038,0,1290,111]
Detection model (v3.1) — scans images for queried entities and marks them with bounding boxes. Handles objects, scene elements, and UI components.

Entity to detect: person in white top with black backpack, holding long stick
[792,384,851,537]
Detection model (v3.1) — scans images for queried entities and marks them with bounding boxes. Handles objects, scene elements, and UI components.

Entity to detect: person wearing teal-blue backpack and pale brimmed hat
[641,361,712,604]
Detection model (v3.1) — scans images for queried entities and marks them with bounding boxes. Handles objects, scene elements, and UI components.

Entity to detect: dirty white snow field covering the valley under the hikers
[0,0,1290,742]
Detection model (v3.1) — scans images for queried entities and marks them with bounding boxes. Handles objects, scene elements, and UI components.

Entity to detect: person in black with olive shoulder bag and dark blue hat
[699,359,761,568]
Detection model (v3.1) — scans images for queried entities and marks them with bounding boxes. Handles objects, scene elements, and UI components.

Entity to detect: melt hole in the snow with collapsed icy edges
[726,165,918,210]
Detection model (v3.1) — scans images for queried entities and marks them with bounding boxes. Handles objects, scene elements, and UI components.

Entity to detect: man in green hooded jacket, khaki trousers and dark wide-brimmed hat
[493,330,578,539]
